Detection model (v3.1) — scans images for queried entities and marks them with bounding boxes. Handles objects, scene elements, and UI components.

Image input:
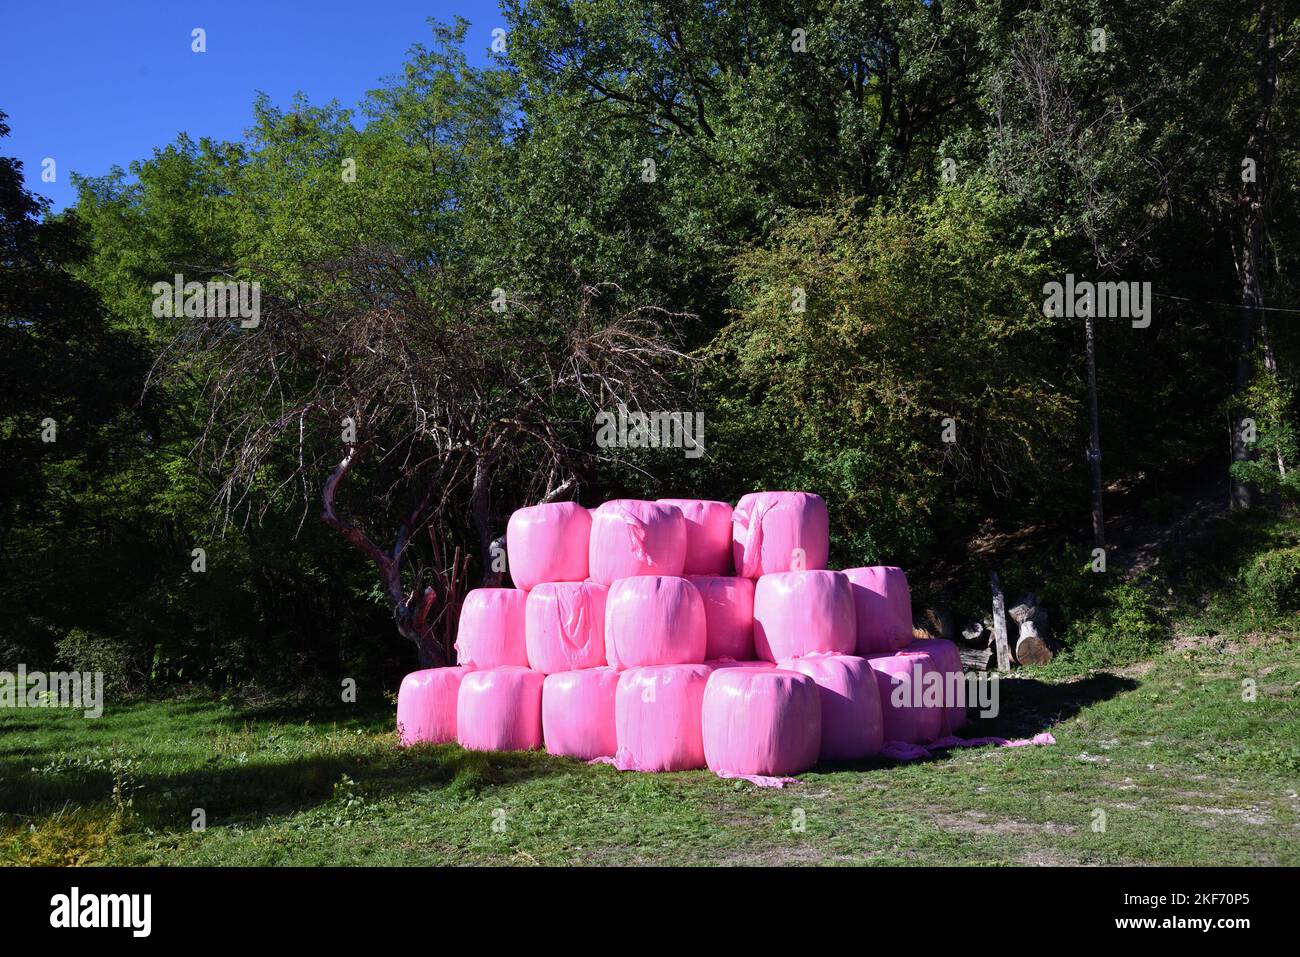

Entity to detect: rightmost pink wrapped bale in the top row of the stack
[732,492,831,579]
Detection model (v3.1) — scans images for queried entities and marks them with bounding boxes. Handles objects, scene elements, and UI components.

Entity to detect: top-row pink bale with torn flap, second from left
[589,498,686,585]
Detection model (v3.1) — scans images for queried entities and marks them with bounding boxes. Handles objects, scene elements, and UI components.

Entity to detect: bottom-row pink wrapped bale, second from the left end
[456,666,546,752]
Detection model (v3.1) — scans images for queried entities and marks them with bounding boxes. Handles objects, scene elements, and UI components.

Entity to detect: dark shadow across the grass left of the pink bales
[0,700,568,830]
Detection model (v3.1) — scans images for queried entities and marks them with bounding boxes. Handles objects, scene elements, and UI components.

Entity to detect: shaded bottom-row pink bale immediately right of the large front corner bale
[780,654,885,761]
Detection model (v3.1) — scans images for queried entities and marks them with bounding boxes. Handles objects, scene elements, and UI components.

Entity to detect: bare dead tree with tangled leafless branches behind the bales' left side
[155,248,686,667]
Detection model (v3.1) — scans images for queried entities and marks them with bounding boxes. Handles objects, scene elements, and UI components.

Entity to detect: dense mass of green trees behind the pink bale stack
[0,0,1300,687]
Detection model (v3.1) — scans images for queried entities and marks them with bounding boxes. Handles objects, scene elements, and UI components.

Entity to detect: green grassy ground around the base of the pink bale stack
[0,637,1300,865]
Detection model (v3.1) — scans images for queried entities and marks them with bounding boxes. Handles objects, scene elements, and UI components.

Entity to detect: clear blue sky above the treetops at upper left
[0,0,504,209]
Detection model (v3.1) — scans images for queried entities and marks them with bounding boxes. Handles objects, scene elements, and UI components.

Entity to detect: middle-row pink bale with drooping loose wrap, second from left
[524,581,610,675]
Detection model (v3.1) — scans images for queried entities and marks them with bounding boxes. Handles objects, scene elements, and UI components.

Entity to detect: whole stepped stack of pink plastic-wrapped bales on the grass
[397,492,966,776]
